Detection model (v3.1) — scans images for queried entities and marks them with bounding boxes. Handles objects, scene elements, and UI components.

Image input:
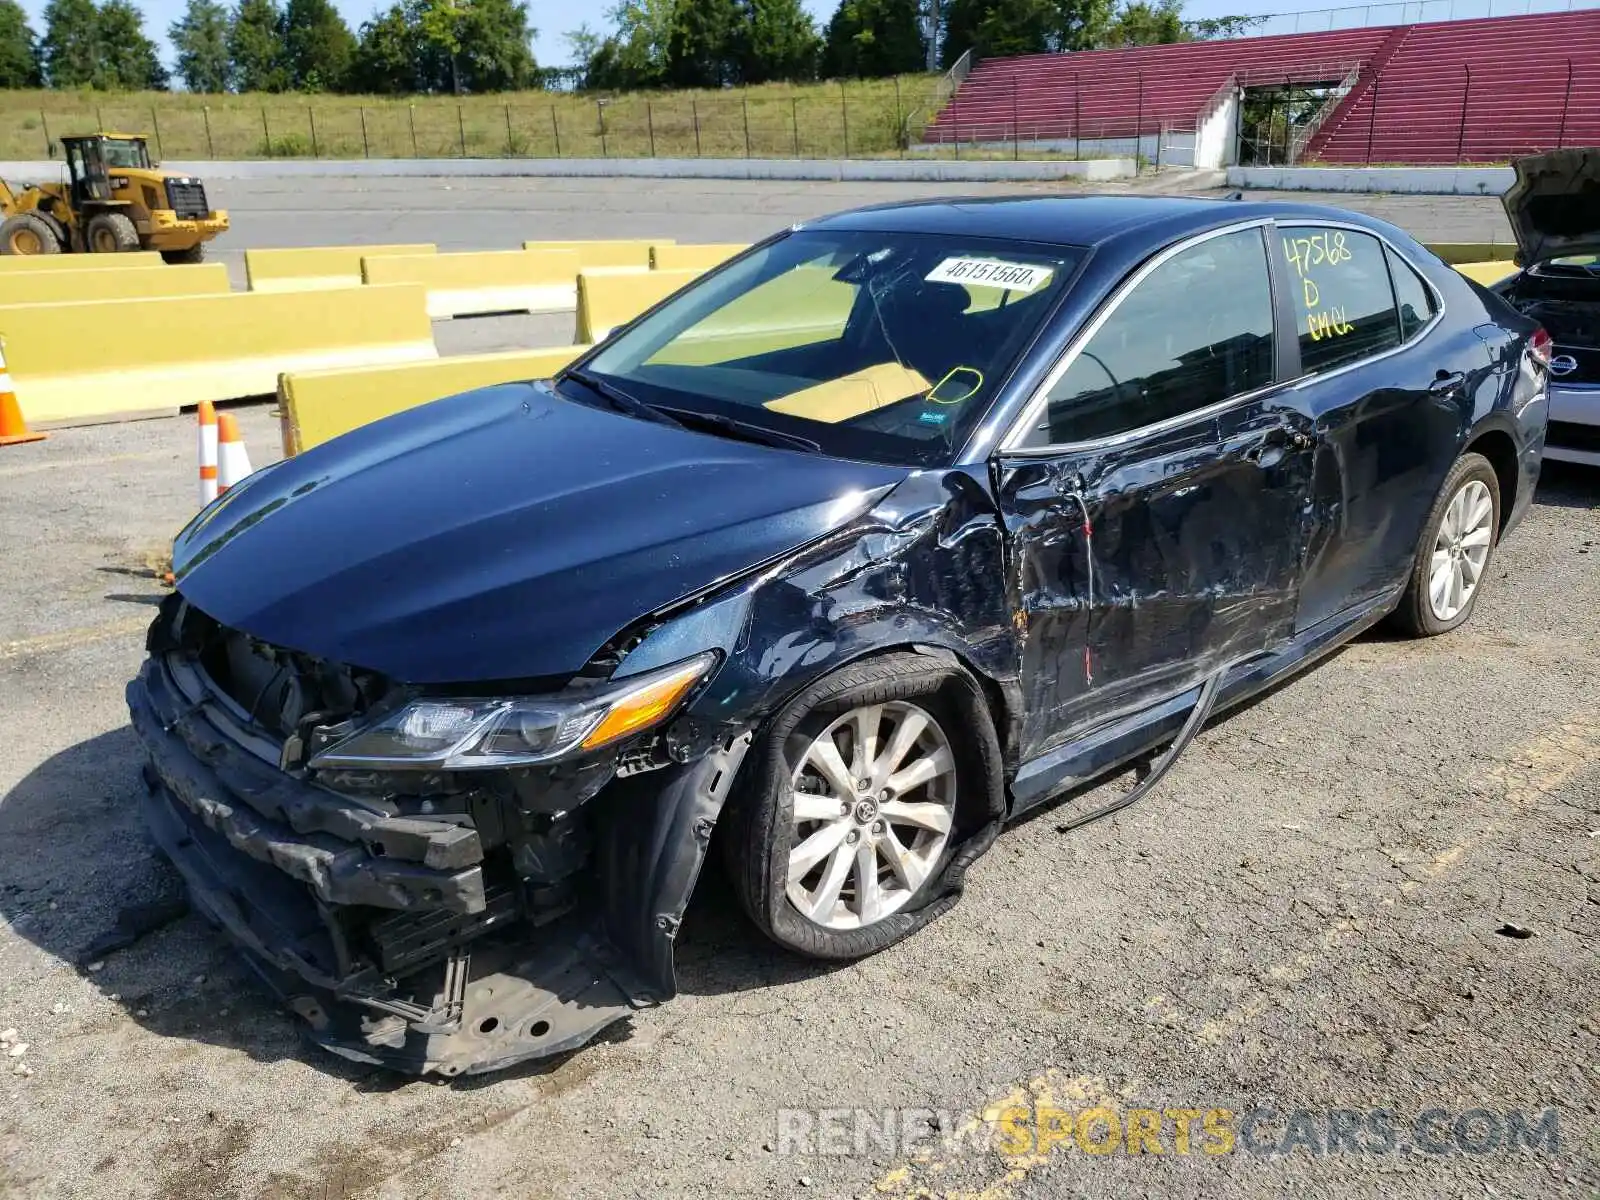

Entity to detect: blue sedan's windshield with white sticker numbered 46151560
[569,230,1082,466]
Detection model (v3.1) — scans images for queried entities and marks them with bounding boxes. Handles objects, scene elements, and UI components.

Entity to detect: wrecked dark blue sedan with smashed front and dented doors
[128,197,1550,1075]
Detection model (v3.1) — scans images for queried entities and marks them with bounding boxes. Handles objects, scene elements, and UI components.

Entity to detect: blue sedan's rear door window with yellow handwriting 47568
[1274,226,1400,373]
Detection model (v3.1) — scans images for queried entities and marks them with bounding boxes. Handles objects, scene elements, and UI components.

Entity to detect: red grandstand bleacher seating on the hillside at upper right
[923,10,1600,163]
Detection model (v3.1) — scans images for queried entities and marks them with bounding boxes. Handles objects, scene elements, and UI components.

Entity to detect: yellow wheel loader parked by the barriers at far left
[0,133,227,262]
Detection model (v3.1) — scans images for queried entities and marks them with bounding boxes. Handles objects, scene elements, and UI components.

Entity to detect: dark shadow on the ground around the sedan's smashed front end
[0,728,835,1093]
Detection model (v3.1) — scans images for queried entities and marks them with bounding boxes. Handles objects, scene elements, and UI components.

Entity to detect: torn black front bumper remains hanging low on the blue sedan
[128,654,654,1075]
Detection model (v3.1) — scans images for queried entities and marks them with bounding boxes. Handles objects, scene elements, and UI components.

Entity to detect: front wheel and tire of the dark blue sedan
[723,654,987,958]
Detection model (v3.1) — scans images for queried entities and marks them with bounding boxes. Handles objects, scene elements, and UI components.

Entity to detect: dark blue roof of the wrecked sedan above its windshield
[802,195,1392,254]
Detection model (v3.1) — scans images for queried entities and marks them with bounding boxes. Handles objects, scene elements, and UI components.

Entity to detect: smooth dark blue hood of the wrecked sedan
[173,382,907,683]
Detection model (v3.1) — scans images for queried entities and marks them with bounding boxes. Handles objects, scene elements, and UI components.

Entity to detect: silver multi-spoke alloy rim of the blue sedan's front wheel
[786,701,957,930]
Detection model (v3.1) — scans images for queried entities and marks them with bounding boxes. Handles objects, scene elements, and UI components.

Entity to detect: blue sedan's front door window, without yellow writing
[1029,229,1274,446]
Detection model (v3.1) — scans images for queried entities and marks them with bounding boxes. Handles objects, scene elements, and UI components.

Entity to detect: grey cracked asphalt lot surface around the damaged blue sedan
[0,181,1600,1200]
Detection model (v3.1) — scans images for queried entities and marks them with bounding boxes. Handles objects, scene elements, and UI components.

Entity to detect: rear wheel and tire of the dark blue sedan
[1394,453,1501,637]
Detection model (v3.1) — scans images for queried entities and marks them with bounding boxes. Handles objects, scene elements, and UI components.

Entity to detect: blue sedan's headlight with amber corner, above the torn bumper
[310,653,717,771]
